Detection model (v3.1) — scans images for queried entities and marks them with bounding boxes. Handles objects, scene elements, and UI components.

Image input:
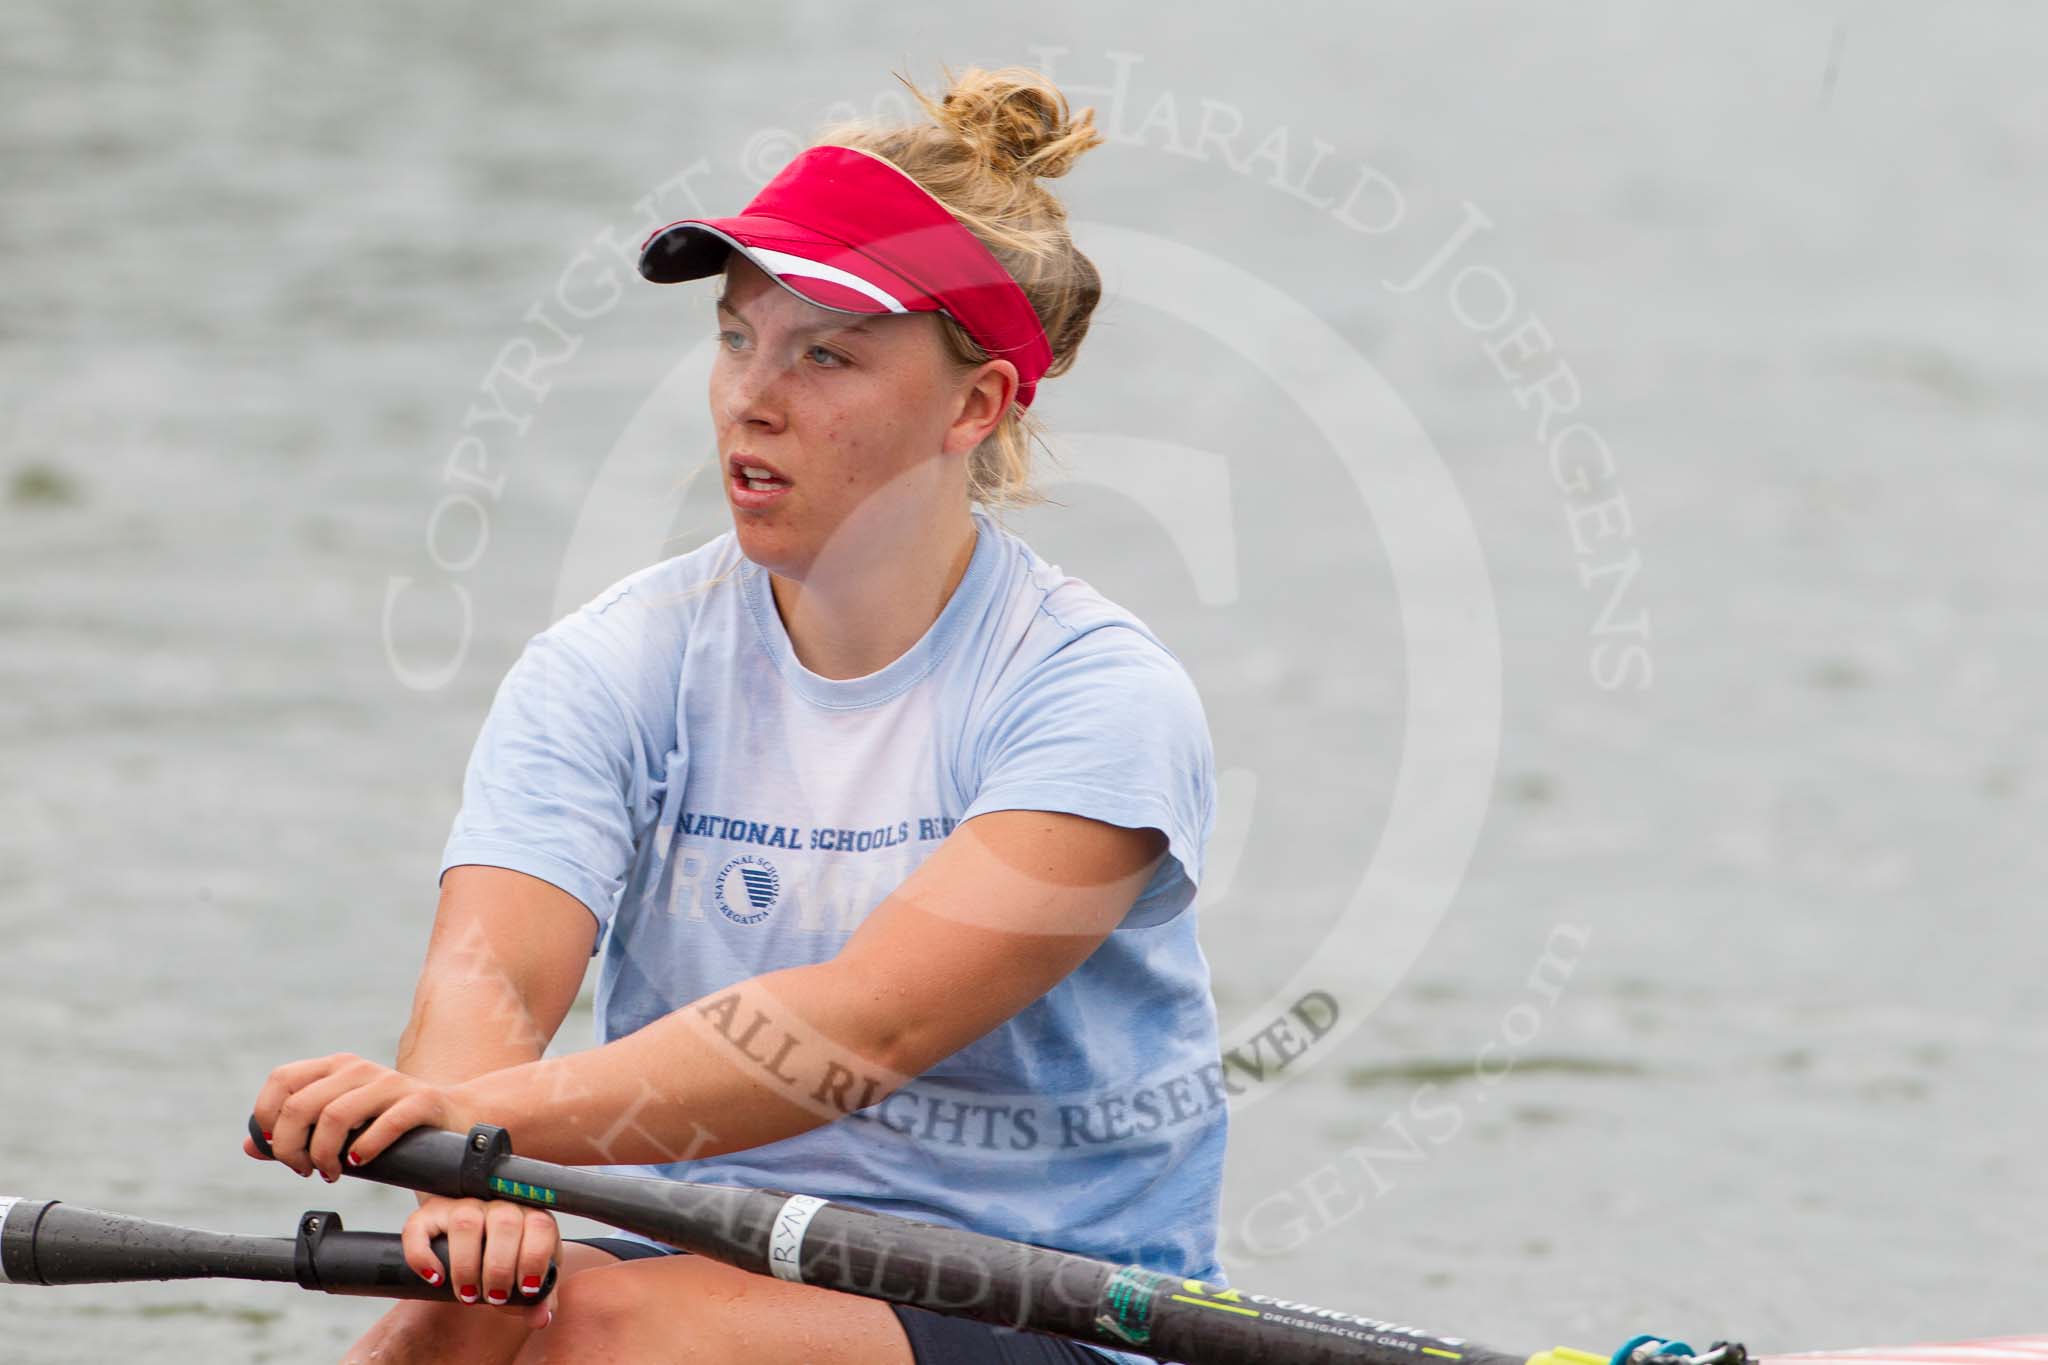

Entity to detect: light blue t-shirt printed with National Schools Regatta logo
[442,512,1227,1281]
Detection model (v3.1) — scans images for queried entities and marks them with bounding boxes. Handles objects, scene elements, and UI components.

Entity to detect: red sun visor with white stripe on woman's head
[639,147,1053,407]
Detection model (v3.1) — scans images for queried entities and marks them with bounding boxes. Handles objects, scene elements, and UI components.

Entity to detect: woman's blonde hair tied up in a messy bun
[815,65,1104,510]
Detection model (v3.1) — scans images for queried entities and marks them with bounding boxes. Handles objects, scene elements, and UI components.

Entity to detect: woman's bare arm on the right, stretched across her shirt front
[440,810,1165,1162]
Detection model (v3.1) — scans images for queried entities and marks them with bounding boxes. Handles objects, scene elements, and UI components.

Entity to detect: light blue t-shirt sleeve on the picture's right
[961,626,1217,927]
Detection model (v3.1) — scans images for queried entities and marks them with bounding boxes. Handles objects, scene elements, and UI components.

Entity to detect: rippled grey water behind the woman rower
[0,0,2048,1361]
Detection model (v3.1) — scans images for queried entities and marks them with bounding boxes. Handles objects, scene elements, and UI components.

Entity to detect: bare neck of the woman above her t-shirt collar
[768,516,977,679]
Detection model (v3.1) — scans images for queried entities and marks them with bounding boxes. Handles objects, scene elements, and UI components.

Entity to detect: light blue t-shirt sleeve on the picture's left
[440,604,672,929]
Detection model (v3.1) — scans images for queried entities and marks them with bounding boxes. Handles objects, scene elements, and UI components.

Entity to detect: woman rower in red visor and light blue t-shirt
[250,68,1225,1365]
